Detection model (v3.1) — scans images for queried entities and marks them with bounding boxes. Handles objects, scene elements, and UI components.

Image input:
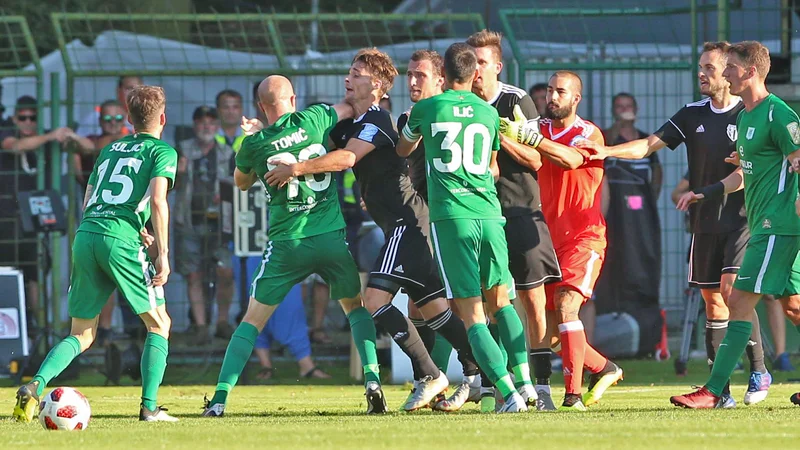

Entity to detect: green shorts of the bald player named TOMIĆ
[250,229,361,305]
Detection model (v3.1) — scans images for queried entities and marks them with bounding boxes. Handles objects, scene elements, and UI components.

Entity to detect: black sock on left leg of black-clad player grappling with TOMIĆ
[372,303,441,378]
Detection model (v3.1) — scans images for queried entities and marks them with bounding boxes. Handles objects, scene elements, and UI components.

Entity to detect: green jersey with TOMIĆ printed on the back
[236,105,345,241]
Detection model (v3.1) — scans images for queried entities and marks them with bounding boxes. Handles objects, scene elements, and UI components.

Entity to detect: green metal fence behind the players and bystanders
[0,0,800,376]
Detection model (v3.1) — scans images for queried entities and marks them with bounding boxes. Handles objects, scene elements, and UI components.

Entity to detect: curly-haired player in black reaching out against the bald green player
[266,48,478,411]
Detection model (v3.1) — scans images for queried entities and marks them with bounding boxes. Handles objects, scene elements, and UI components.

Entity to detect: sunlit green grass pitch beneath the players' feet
[0,362,800,450]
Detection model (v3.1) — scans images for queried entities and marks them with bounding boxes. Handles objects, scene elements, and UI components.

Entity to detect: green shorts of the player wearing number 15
[68,231,164,319]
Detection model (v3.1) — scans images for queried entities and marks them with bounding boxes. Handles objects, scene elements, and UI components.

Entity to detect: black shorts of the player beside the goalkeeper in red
[505,211,561,290]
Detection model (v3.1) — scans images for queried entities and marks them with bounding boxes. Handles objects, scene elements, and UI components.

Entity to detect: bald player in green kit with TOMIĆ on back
[203,75,386,417]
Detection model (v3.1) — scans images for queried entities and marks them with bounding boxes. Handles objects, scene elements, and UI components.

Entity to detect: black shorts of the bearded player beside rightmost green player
[689,227,750,289]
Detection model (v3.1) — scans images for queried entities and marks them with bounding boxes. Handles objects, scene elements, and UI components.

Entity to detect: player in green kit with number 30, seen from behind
[397,43,533,412]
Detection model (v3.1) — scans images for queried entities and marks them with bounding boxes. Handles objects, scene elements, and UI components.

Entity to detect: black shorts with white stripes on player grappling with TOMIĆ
[367,225,444,307]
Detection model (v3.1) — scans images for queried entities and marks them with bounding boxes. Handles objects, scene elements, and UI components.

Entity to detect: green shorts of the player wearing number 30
[431,218,511,299]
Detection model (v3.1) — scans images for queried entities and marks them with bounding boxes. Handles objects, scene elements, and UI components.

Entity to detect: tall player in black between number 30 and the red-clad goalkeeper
[467,30,561,410]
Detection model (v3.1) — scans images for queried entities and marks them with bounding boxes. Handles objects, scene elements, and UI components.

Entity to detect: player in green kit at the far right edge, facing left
[670,41,800,408]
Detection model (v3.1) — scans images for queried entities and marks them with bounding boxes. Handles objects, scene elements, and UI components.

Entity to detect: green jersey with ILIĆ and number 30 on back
[402,90,501,221]
